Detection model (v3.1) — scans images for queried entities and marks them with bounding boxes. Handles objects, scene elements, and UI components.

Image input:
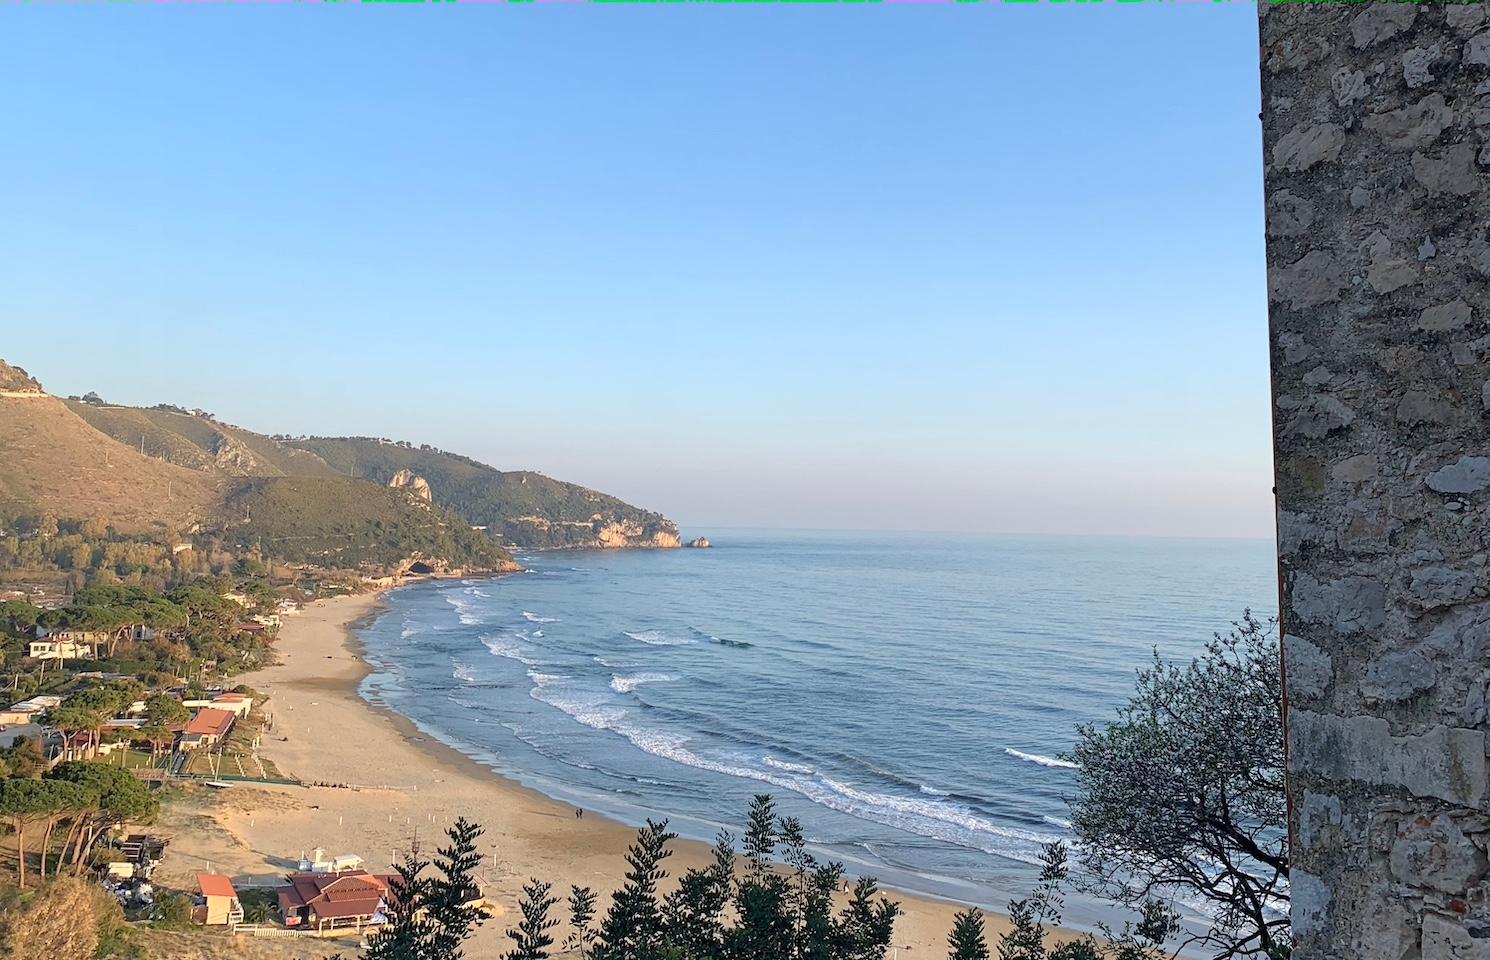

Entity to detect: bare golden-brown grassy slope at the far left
[0,397,222,531]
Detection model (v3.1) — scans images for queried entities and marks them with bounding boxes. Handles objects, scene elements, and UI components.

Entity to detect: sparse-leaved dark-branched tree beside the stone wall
[1071,611,1289,957]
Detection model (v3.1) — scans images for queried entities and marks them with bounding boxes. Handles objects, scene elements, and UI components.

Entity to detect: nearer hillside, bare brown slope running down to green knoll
[0,362,513,569]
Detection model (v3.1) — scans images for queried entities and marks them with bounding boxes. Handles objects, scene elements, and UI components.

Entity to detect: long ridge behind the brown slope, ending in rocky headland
[35,367,681,550]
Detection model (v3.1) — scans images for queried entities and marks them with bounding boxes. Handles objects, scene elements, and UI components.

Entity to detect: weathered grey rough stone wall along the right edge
[1259,3,1490,960]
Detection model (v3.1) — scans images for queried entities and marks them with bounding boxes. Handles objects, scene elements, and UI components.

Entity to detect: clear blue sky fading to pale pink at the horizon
[0,3,1272,537]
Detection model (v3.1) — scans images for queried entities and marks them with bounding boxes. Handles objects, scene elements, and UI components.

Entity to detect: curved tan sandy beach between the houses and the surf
[159,593,1048,960]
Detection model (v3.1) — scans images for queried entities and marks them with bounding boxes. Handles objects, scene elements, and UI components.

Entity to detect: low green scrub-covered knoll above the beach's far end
[225,477,511,569]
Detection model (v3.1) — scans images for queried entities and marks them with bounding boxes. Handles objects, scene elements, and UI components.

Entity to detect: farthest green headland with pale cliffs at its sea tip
[286,437,678,550]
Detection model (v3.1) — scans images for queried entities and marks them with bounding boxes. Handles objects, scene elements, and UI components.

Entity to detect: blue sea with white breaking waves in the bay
[361,531,1277,929]
